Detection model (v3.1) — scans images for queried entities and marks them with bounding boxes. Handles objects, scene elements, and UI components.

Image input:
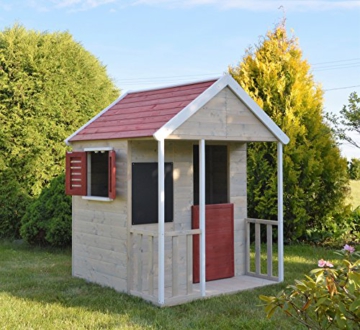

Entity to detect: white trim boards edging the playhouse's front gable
[154,74,290,144]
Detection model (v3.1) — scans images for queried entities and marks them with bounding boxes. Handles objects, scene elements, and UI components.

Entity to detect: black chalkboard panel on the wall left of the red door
[132,163,174,225]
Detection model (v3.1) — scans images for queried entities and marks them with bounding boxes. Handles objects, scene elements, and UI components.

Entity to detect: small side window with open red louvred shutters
[65,148,116,200]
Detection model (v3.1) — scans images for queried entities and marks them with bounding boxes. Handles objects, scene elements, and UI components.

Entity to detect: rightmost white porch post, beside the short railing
[277,142,284,282]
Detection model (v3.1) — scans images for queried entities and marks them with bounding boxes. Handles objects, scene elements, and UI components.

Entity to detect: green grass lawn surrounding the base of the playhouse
[0,241,344,330]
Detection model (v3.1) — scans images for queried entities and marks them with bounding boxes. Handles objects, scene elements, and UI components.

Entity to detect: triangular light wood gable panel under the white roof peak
[168,87,276,141]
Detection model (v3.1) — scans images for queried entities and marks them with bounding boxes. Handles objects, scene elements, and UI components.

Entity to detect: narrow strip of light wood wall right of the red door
[229,142,247,276]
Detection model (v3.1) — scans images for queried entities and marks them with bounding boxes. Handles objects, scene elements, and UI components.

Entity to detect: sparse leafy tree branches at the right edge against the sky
[327,92,360,148]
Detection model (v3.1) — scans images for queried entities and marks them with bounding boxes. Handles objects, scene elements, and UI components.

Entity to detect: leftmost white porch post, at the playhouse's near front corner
[158,139,165,305]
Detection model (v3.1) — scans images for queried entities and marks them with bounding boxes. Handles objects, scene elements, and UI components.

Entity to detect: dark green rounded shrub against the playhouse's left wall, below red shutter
[20,174,71,247]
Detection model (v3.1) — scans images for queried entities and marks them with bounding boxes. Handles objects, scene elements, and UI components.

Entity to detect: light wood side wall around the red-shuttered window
[72,140,128,291]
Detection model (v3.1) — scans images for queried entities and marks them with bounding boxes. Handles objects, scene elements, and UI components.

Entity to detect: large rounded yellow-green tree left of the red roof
[0,25,119,237]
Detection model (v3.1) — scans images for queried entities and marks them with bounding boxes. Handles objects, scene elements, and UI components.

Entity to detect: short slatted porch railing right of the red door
[245,218,279,281]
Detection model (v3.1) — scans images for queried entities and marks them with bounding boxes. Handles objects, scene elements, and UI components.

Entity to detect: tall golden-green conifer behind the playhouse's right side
[229,24,348,239]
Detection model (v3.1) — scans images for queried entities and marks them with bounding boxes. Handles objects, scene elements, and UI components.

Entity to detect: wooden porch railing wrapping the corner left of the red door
[128,228,201,305]
